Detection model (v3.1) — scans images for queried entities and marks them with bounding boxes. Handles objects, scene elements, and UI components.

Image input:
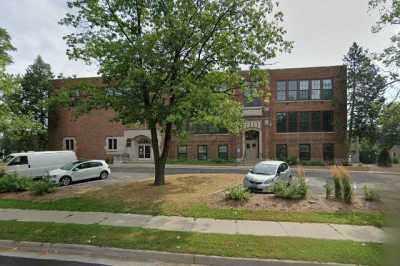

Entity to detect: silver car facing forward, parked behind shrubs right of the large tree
[243,161,292,192]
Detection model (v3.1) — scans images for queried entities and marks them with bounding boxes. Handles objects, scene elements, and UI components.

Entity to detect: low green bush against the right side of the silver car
[273,177,308,200]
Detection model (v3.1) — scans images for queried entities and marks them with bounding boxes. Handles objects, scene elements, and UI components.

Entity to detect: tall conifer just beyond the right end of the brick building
[344,43,386,143]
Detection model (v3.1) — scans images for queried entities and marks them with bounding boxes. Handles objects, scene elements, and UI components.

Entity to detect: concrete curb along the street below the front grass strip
[0,240,355,266]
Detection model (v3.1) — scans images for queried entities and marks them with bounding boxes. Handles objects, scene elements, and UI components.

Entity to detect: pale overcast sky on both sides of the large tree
[0,0,394,77]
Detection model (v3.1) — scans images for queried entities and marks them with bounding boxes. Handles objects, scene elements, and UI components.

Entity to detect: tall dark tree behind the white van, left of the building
[5,56,54,150]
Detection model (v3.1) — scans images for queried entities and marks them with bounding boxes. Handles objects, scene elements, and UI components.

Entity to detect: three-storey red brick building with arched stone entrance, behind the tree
[49,66,346,161]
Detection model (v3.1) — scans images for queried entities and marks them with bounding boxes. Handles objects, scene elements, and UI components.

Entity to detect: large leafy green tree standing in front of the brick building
[60,0,292,185]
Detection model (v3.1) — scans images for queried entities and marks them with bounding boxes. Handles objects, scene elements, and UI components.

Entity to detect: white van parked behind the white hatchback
[6,151,77,178]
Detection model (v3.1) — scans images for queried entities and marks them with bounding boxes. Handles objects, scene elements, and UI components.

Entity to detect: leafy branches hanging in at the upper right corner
[369,0,400,100]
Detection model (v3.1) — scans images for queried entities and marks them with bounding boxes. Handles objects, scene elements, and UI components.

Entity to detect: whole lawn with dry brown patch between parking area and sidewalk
[0,174,384,227]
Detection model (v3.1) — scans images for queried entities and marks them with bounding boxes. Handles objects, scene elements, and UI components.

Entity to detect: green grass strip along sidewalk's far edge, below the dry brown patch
[0,197,384,227]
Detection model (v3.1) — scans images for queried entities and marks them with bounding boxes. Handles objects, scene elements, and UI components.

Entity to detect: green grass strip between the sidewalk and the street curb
[0,221,384,266]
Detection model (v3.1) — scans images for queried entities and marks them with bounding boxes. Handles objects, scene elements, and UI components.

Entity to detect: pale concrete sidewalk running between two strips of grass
[0,209,384,243]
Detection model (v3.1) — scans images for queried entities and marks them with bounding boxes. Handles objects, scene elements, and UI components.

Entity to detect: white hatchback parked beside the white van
[49,160,111,186]
